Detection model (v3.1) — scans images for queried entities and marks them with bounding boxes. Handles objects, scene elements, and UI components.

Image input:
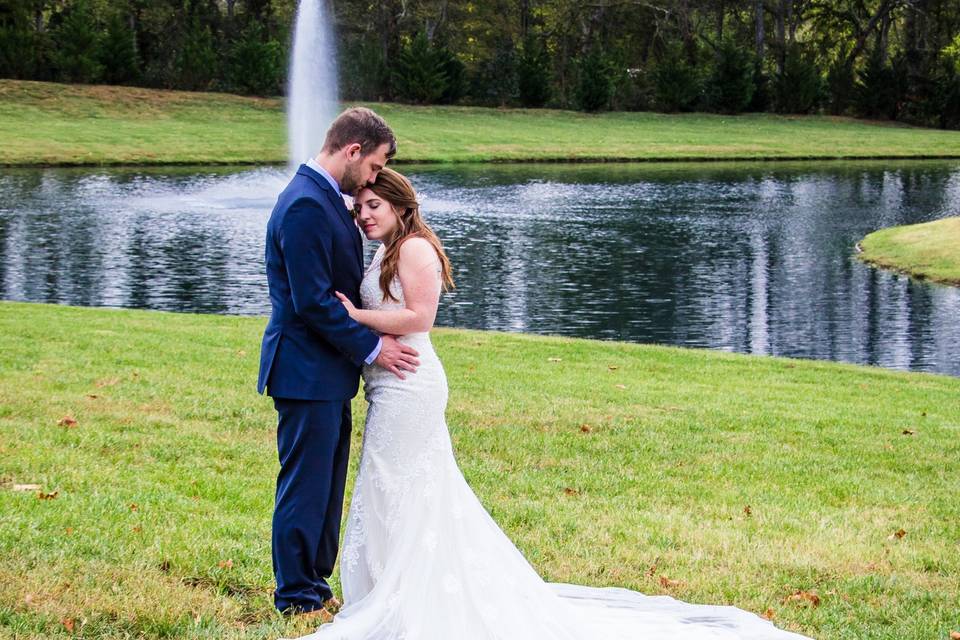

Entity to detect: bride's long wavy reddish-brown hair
[365,168,454,302]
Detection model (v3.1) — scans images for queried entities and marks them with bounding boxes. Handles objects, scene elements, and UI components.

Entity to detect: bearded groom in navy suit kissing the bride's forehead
[257,108,419,613]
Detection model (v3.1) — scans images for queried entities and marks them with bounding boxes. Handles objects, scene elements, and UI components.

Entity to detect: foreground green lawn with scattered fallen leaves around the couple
[0,303,960,640]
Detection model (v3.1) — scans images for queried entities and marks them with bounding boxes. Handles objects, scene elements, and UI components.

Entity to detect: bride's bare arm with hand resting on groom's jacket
[337,238,441,336]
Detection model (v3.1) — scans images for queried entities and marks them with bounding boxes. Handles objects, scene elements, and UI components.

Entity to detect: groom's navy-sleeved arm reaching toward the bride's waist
[279,199,382,365]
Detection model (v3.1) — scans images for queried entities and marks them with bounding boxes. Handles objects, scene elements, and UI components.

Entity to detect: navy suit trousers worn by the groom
[273,398,351,612]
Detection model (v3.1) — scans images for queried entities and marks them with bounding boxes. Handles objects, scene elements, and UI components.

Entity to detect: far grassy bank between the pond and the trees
[0,80,960,165]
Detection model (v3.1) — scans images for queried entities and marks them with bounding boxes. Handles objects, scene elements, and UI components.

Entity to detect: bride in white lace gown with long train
[298,169,803,640]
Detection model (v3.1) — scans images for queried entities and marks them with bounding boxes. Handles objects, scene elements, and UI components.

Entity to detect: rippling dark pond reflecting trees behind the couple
[0,161,960,375]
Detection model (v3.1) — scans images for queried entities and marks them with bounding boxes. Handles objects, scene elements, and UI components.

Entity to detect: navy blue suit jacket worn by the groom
[257,165,379,400]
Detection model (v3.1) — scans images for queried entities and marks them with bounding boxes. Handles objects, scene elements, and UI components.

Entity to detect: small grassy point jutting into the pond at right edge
[859,217,960,286]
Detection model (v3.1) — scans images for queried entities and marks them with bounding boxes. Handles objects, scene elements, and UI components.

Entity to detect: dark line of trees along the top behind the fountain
[0,0,960,128]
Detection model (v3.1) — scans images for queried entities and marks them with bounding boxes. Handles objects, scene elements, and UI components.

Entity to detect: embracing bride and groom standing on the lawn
[258,108,802,640]
